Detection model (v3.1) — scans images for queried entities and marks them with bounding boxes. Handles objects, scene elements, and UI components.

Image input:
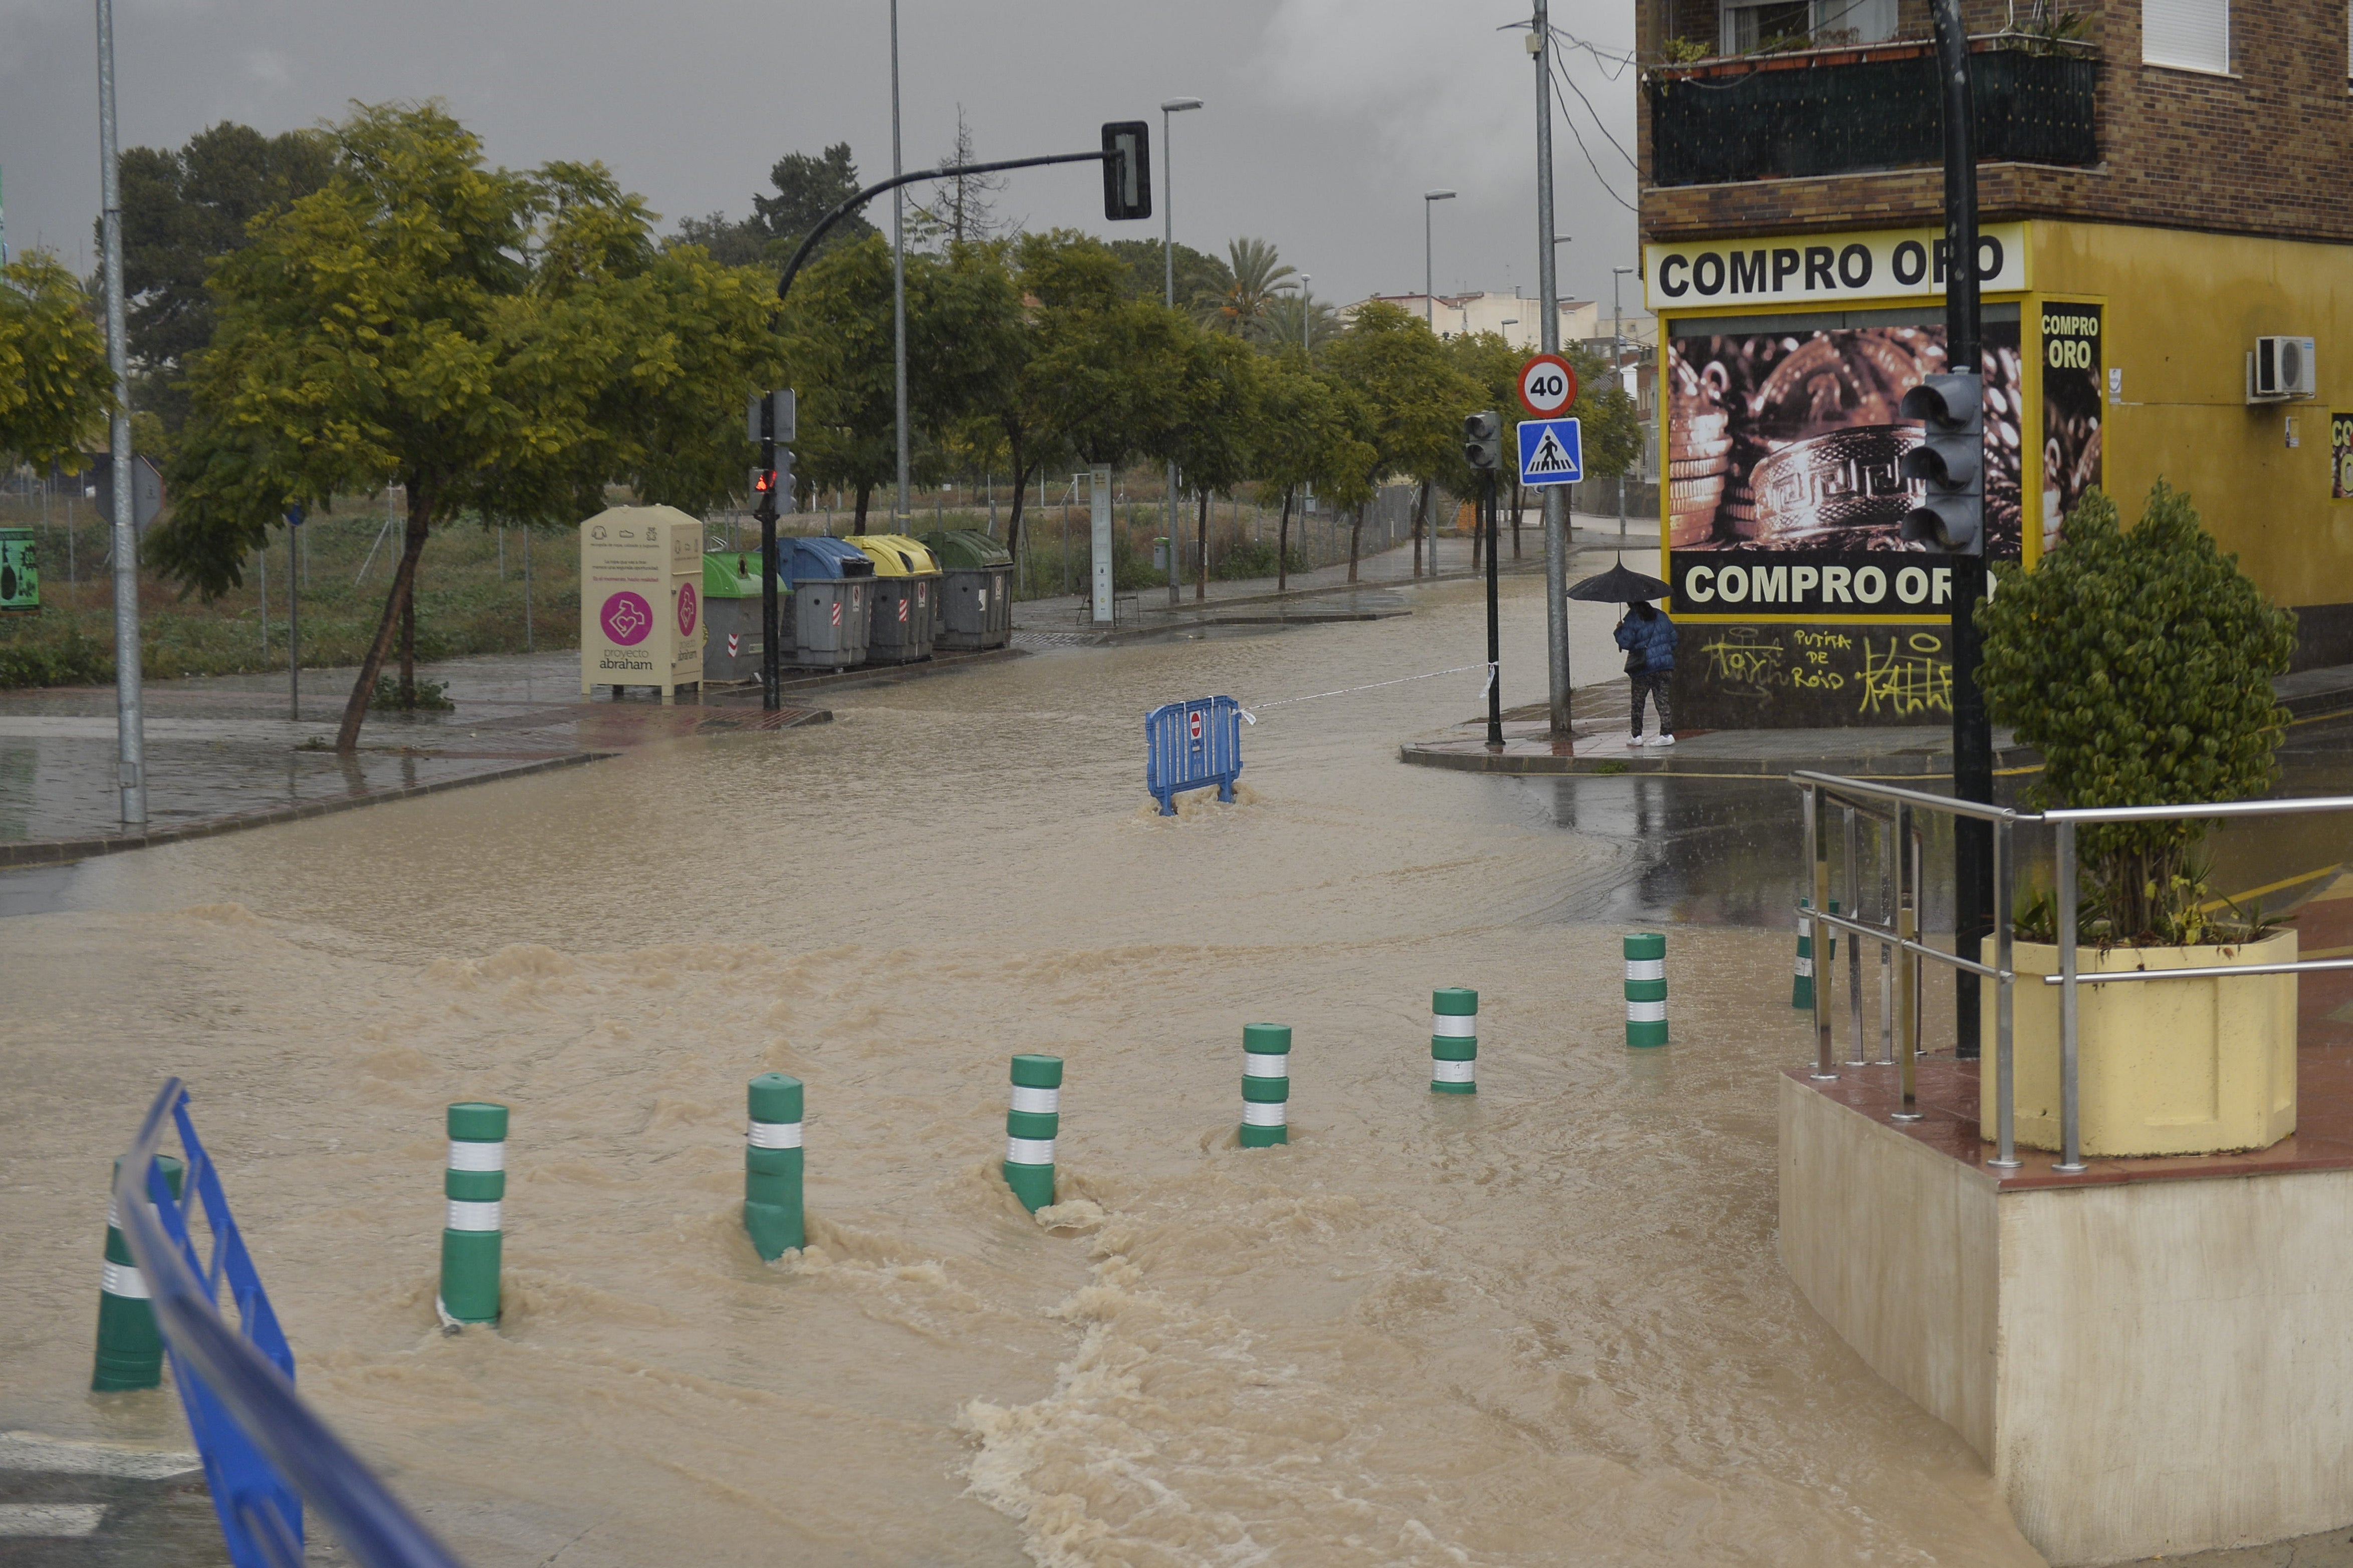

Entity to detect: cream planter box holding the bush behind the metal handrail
[1979,931,2296,1157]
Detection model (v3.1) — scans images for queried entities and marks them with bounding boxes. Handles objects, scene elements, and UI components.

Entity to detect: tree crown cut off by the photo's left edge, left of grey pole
[0,251,115,468]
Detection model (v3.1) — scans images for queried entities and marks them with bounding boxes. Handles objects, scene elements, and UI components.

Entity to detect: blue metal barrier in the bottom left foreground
[115,1079,461,1568]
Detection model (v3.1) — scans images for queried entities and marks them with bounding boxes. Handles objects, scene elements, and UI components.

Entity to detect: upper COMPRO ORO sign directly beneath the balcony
[1642,223,2026,310]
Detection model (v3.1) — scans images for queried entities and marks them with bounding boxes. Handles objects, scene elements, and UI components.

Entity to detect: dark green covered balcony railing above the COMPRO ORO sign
[1642,42,2099,186]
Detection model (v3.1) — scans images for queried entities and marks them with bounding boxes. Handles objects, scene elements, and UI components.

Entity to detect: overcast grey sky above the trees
[0,0,1637,301]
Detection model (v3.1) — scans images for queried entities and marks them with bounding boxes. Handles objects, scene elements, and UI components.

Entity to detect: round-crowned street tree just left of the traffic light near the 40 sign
[1322,299,1480,583]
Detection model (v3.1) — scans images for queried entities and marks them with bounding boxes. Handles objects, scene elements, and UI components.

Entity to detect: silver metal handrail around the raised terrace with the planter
[1791,768,2353,1173]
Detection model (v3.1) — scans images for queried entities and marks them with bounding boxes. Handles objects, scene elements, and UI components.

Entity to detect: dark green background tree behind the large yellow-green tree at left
[112,120,332,435]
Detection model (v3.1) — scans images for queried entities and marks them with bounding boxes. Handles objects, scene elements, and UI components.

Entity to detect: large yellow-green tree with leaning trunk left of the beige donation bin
[153,103,777,752]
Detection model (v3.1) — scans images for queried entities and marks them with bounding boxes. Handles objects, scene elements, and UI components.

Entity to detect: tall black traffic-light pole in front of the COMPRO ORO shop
[1934,0,1993,1060]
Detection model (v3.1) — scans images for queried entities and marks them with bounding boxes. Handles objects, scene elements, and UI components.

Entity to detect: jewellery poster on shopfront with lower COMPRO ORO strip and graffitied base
[1666,322,2026,729]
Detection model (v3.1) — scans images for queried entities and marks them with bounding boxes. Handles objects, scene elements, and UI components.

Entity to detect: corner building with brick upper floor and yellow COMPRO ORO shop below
[1637,0,2353,724]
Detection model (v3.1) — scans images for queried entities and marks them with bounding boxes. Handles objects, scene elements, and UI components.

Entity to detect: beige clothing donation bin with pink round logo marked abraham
[581,505,703,698]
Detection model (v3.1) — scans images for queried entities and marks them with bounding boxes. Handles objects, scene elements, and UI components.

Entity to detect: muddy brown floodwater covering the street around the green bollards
[0,583,2040,1568]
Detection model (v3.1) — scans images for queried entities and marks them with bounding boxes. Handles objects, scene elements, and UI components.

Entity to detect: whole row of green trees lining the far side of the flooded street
[0,103,1640,750]
